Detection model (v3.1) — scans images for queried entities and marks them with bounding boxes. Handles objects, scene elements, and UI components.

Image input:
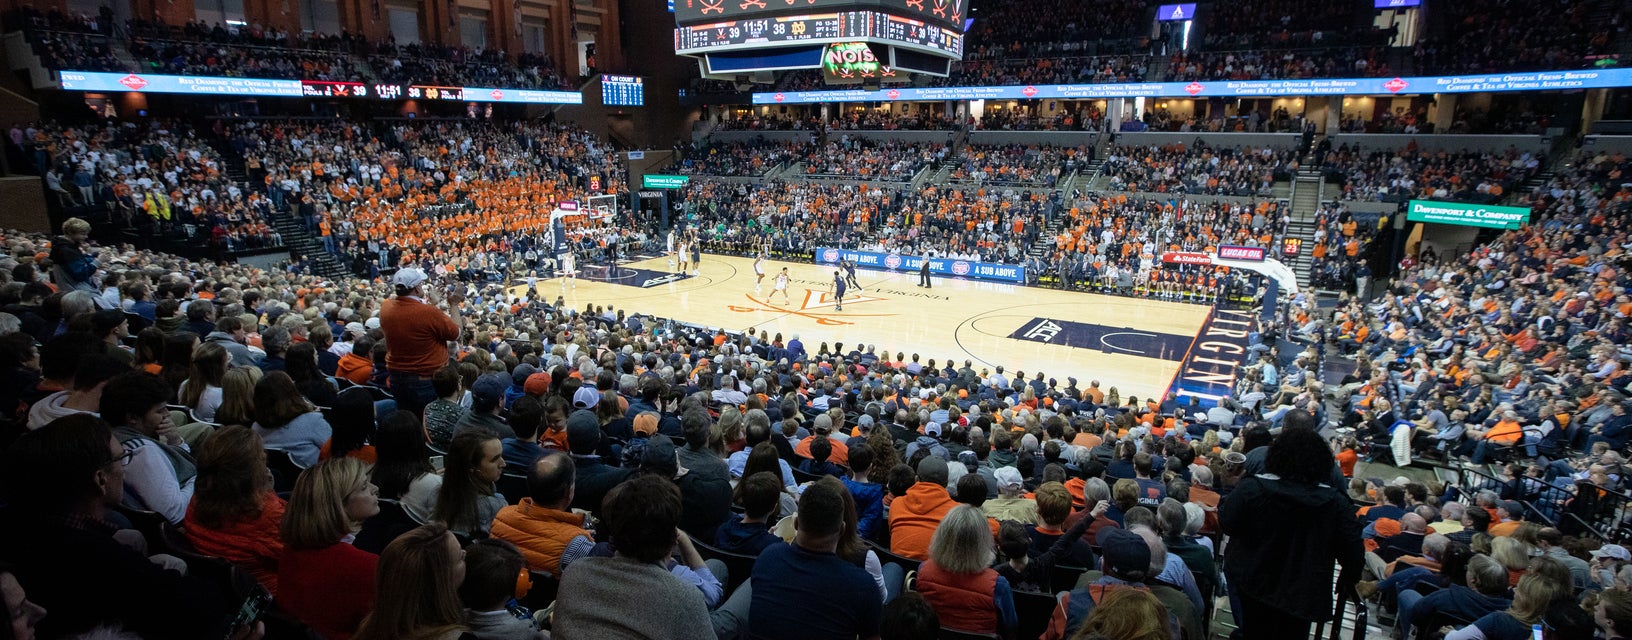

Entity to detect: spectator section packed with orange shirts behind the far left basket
[227,121,627,274]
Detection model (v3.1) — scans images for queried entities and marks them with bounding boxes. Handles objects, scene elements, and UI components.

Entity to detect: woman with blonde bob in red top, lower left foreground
[277,457,380,640]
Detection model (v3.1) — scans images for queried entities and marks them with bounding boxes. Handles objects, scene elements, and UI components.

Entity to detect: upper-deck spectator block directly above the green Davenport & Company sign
[1322,145,1541,204]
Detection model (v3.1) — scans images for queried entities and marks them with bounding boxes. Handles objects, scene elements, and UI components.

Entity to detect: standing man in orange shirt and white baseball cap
[380,266,460,415]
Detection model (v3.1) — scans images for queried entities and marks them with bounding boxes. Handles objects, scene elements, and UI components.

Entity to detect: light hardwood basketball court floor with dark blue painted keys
[517,255,1211,398]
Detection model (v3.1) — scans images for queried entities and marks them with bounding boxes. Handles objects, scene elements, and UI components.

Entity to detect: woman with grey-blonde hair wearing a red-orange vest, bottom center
[916,504,1020,637]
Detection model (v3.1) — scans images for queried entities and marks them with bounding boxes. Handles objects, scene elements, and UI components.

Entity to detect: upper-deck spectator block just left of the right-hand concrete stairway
[1102,140,1297,196]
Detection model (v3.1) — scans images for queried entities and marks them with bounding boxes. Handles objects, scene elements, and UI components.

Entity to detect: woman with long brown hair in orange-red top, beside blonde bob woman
[181,424,284,596]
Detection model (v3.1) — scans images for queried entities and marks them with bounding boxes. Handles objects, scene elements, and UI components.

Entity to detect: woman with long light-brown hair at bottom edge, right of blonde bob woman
[353,522,467,640]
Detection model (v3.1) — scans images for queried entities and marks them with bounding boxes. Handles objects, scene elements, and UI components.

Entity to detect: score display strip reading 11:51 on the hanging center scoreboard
[674,10,963,59]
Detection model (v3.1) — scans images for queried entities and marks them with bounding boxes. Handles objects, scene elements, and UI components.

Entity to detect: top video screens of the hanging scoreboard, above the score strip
[674,0,969,33]
